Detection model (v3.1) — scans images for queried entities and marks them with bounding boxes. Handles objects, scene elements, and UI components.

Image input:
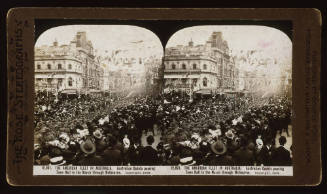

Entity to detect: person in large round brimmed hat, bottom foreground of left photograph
[77,139,104,166]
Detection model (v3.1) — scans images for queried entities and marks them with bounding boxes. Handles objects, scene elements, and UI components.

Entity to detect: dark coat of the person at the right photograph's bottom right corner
[272,146,292,166]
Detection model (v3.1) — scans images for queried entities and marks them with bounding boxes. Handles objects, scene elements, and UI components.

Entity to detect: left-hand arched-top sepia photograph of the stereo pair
[34,25,164,166]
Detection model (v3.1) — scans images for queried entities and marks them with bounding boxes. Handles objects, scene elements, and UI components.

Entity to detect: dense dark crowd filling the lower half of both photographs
[34,89,292,166]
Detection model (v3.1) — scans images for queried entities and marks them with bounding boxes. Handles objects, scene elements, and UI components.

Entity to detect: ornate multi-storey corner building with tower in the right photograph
[164,32,235,93]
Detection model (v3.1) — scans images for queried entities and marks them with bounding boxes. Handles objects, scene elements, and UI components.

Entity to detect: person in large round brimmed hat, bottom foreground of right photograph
[204,140,234,166]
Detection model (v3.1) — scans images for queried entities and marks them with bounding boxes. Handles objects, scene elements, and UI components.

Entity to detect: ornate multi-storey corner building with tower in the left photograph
[34,32,104,93]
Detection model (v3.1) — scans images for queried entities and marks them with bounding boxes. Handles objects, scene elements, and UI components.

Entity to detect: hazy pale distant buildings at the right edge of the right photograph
[233,50,291,96]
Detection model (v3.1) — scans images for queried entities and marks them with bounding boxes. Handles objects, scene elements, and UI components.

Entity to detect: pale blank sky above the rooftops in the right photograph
[167,25,292,66]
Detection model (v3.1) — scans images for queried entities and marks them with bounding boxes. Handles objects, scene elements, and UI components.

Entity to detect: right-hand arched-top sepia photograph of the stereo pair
[163,25,294,166]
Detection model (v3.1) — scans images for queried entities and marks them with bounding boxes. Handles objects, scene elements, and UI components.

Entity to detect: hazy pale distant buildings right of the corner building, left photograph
[100,48,162,96]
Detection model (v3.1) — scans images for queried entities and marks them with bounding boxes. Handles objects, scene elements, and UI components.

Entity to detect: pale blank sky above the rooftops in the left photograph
[35,25,163,56]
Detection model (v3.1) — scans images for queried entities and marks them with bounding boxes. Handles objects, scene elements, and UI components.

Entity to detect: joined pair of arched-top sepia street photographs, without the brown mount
[34,25,292,176]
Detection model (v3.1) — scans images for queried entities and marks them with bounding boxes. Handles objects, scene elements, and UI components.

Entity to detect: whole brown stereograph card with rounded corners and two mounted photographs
[7,7,321,186]
